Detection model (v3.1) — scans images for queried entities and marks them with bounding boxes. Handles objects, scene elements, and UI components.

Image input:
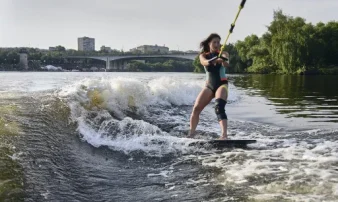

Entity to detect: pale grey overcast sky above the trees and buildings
[0,0,338,51]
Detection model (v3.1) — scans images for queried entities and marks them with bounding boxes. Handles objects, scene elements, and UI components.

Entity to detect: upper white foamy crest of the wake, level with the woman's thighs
[58,77,201,113]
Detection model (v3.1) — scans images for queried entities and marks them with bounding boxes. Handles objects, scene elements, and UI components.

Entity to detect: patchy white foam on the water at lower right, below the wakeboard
[195,136,338,201]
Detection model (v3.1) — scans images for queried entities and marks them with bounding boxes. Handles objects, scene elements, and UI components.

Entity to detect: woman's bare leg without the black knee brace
[188,88,214,138]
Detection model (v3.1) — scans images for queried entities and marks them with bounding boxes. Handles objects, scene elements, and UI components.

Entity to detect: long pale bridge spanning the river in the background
[65,53,198,70]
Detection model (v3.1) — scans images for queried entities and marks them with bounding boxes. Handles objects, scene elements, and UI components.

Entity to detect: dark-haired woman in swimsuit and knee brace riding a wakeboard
[188,33,229,139]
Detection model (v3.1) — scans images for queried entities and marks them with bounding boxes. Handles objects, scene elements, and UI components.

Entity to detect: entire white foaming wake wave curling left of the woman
[57,77,242,155]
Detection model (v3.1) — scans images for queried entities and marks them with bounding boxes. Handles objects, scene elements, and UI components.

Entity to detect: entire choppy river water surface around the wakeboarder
[0,72,338,202]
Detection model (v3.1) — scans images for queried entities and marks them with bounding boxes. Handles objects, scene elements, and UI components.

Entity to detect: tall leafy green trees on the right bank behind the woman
[194,10,338,74]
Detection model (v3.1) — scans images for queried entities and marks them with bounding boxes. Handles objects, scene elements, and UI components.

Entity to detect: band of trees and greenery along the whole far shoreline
[0,10,338,75]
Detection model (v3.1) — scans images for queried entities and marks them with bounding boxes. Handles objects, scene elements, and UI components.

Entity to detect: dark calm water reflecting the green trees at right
[234,75,338,123]
